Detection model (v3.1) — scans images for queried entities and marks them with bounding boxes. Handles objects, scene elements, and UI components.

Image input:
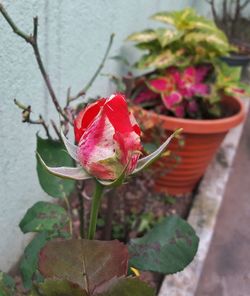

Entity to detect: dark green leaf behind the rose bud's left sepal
[37,136,75,198]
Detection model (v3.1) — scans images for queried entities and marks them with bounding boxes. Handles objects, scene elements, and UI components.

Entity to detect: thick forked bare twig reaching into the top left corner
[0,4,73,124]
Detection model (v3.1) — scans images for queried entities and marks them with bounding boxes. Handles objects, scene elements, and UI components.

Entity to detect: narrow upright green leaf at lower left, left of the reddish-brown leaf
[20,232,50,289]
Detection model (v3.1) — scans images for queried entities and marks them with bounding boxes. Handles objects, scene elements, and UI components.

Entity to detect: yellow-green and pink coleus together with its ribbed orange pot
[128,8,247,194]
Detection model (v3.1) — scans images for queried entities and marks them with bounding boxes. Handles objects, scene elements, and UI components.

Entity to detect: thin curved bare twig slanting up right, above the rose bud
[67,33,115,105]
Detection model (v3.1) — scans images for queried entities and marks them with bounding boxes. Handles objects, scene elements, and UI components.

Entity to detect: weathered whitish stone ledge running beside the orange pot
[158,101,249,296]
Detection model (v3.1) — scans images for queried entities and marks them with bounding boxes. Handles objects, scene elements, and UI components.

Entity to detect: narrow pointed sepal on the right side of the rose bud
[132,129,182,175]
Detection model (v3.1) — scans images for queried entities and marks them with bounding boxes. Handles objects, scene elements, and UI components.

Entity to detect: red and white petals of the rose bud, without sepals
[74,94,141,180]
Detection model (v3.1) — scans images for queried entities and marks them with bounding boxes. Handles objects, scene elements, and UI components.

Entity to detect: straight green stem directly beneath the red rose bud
[88,181,104,239]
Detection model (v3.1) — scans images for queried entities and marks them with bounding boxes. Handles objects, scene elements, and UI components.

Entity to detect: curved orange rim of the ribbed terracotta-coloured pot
[134,96,246,134]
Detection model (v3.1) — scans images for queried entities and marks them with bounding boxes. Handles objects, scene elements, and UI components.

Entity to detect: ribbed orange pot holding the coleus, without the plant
[133,96,245,195]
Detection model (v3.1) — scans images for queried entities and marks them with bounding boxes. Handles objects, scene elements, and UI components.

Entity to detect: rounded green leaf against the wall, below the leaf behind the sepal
[19,201,69,233]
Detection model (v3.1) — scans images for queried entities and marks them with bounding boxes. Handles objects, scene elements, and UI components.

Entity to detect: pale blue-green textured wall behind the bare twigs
[0,0,192,271]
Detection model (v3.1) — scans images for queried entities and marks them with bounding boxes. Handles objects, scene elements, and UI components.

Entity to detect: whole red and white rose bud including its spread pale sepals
[37,94,180,187]
